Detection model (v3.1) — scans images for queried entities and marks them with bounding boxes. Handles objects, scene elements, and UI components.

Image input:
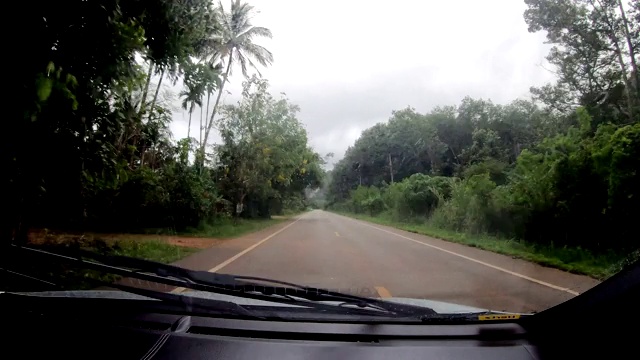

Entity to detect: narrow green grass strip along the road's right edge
[336,212,627,280]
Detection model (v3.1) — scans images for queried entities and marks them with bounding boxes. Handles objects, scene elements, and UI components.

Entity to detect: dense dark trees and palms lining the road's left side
[1,0,322,245]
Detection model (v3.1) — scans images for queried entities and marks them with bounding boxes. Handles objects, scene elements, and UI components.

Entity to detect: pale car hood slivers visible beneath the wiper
[7,290,495,314]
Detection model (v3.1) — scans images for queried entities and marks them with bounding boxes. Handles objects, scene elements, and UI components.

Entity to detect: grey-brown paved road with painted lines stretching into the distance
[171,210,598,312]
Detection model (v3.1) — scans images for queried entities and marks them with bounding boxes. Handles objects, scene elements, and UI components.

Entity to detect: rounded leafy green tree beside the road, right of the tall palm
[216,76,321,216]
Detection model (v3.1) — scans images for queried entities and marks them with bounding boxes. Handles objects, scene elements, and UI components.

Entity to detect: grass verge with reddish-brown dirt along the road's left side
[6,214,297,291]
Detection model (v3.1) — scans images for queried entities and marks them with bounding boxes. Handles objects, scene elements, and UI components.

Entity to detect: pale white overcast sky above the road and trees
[171,0,553,166]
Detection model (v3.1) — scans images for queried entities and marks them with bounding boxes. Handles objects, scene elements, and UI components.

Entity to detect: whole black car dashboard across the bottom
[0,258,640,360]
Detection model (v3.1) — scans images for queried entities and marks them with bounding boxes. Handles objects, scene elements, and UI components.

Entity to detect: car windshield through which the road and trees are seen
[0,0,640,316]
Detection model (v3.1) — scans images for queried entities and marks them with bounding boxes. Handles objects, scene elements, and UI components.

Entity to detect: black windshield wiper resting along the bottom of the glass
[7,245,437,320]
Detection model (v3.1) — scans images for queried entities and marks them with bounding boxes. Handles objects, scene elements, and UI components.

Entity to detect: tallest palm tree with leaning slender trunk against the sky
[200,0,273,158]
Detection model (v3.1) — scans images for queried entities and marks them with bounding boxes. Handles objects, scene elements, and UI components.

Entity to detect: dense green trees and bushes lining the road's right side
[326,0,640,251]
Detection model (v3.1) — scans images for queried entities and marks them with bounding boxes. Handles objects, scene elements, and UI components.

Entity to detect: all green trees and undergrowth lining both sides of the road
[0,0,640,288]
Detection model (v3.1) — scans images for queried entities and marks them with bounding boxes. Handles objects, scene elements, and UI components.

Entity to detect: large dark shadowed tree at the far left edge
[1,0,229,245]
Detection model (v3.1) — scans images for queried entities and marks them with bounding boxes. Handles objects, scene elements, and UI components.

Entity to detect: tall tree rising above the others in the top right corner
[524,0,640,122]
